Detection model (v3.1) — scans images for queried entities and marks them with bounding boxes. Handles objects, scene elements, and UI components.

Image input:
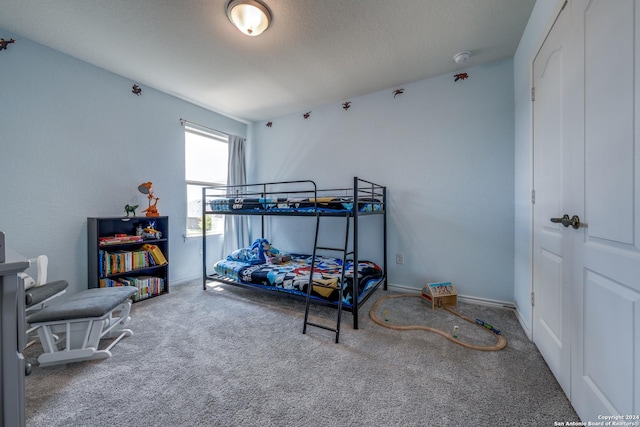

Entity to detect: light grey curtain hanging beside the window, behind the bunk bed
[223,135,249,256]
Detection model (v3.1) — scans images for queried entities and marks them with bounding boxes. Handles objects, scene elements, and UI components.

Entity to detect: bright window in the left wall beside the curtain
[184,125,229,237]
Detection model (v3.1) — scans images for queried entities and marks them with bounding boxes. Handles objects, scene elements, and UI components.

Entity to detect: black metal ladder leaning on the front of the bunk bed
[302,214,353,343]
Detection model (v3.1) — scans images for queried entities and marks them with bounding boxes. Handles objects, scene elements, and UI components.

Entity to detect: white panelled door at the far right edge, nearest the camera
[563,0,640,425]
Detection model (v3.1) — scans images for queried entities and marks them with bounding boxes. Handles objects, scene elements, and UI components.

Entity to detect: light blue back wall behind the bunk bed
[249,60,514,302]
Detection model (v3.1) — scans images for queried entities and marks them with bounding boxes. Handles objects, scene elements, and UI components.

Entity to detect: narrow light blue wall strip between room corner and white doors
[513,0,564,336]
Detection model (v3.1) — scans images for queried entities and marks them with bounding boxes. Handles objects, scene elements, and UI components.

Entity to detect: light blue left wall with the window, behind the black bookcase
[0,31,247,298]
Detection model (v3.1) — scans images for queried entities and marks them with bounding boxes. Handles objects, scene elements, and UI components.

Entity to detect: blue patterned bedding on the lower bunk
[214,254,383,306]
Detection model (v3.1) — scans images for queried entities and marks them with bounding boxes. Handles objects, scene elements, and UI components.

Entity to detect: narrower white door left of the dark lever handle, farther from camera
[533,3,571,396]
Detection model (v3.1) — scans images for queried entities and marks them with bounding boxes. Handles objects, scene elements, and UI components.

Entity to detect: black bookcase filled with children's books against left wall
[87,216,169,301]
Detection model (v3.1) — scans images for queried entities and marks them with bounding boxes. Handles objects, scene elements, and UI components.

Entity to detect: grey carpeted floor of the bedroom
[25,282,579,427]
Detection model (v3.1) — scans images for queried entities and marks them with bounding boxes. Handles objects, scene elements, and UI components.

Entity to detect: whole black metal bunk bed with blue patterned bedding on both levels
[202,177,387,332]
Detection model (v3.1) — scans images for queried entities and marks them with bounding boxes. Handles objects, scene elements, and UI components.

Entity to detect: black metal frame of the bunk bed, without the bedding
[202,177,387,329]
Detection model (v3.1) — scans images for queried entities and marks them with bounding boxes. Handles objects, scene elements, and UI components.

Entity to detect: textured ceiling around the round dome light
[0,0,535,121]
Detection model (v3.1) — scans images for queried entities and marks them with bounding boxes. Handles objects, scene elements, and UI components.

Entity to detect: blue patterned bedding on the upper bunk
[209,197,382,212]
